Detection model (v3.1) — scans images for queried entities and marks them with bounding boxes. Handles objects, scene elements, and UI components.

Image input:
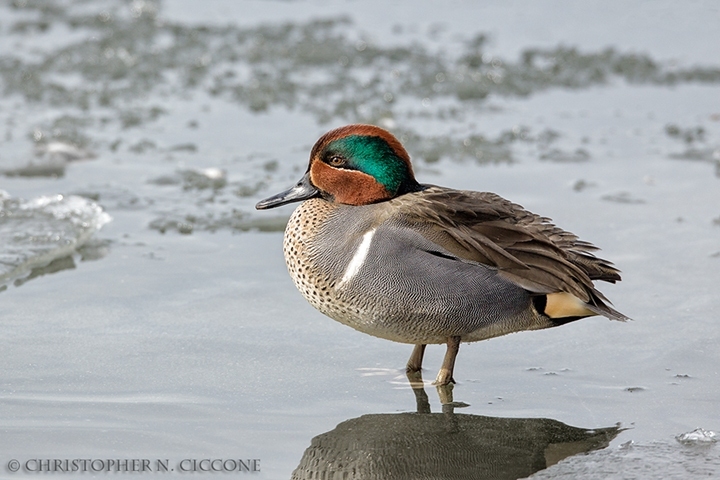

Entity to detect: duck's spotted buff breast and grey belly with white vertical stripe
[284,202,547,344]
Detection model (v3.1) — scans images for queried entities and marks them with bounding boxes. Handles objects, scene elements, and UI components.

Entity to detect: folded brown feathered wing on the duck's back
[394,187,627,320]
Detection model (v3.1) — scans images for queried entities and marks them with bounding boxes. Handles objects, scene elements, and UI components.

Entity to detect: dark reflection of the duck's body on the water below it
[292,390,621,480]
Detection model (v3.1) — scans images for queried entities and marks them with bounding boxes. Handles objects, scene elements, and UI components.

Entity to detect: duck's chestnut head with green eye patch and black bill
[255,125,421,210]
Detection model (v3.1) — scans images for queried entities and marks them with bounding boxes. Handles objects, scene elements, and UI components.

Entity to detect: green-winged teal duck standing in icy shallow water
[256,124,628,386]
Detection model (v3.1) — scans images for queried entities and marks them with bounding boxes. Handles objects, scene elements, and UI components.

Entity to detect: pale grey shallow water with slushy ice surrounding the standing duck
[0,0,720,479]
